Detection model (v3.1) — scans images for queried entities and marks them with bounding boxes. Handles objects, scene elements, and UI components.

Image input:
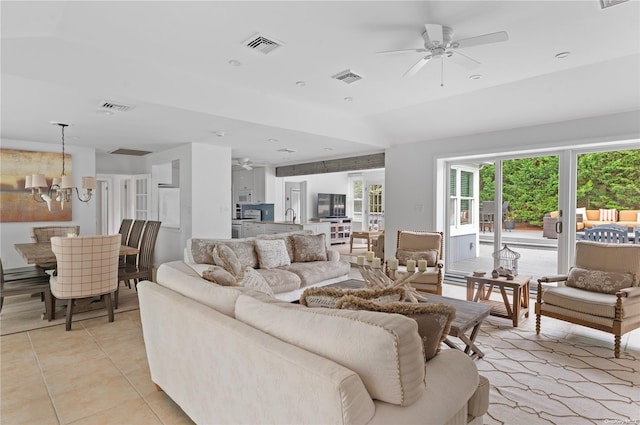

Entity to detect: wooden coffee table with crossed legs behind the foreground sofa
[327,279,491,359]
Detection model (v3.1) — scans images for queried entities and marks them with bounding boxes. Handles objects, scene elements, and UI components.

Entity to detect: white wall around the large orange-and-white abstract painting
[0,139,96,268]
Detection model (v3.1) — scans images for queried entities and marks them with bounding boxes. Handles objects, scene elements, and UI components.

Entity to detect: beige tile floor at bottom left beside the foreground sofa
[0,310,193,425]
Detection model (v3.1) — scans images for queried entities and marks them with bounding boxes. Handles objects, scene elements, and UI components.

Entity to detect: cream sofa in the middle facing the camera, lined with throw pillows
[184,231,351,301]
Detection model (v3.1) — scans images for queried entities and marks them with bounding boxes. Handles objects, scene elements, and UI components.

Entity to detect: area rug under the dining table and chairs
[0,286,139,335]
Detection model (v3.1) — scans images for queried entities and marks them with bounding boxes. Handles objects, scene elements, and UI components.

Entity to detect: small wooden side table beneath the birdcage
[466,273,532,327]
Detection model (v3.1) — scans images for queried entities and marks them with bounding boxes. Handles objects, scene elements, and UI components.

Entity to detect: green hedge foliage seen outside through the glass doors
[480,149,640,226]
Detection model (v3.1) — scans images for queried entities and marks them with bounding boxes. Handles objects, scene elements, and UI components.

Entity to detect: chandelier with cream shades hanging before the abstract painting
[24,123,96,211]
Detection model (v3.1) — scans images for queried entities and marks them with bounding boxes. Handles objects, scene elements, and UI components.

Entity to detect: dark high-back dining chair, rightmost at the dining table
[115,220,162,308]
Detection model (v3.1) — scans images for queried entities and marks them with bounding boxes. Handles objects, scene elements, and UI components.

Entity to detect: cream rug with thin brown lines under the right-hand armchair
[476,314,640,425]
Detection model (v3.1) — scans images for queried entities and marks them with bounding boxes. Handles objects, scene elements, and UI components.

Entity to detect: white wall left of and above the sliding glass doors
[385,111,640,253]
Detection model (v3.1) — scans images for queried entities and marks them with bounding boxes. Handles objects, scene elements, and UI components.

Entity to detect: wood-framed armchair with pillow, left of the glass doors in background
[395,230,444,295]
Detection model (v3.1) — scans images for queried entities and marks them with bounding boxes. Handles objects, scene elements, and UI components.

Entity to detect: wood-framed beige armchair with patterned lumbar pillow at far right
[536,241,640,358]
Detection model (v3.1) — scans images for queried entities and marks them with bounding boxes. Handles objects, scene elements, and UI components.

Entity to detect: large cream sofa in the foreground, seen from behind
[138,262,489,425]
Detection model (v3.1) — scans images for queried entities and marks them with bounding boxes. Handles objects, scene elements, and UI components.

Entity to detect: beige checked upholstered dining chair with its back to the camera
[49,234,121,331]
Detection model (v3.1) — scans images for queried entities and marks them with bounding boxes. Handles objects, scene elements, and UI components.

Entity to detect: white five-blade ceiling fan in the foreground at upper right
[377,24,509,81]
